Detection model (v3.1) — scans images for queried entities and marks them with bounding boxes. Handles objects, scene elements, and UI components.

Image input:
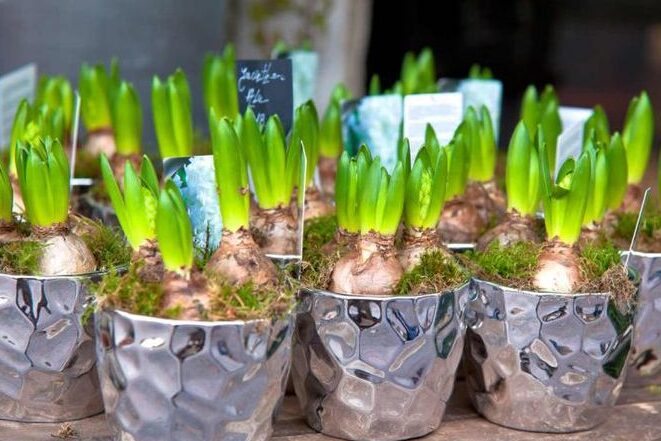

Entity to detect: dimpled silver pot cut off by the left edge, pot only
[0,273,103,422]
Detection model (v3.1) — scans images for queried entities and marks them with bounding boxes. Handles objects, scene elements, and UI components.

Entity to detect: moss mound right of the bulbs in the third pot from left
[395,250,469,295]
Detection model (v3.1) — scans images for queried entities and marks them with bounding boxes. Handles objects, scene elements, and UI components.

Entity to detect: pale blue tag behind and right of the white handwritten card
[438,78,503,143]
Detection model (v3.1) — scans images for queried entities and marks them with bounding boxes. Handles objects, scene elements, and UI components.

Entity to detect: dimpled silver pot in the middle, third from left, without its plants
[292,285,468,441]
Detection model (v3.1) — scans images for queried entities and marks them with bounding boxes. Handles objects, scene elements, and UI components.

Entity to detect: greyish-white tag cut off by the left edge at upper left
[0,63,37,148]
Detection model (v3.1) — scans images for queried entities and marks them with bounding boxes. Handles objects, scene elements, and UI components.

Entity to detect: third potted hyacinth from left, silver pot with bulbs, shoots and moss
[292,149,466,440]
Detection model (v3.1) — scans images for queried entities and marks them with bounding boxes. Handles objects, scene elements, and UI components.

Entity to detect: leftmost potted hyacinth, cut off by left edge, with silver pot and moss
[0,137,128,422]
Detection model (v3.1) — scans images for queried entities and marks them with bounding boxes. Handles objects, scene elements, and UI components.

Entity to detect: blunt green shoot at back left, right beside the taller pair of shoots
[112,81,142,156]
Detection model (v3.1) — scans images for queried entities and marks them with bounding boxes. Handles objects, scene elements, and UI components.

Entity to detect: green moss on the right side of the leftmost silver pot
[81,219,131,270]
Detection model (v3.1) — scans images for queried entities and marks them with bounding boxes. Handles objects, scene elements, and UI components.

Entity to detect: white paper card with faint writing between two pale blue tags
[403,92,464,158]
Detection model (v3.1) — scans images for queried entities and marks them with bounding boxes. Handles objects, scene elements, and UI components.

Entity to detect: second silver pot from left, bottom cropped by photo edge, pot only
[96,311,293,441]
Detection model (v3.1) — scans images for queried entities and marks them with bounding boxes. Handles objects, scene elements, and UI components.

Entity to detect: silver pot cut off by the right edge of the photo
[622,252,661,385]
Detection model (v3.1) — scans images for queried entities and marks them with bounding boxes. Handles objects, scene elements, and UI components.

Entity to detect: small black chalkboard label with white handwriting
[236,59,294,132]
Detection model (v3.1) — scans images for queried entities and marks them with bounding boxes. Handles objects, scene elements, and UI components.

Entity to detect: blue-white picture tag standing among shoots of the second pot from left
[163,155,223,252]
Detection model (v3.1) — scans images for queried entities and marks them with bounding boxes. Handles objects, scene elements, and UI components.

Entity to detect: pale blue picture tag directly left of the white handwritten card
[342,94,402,171]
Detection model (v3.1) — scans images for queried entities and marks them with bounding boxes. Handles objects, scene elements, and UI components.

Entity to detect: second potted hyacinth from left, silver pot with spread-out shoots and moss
[96,113,295,441]
